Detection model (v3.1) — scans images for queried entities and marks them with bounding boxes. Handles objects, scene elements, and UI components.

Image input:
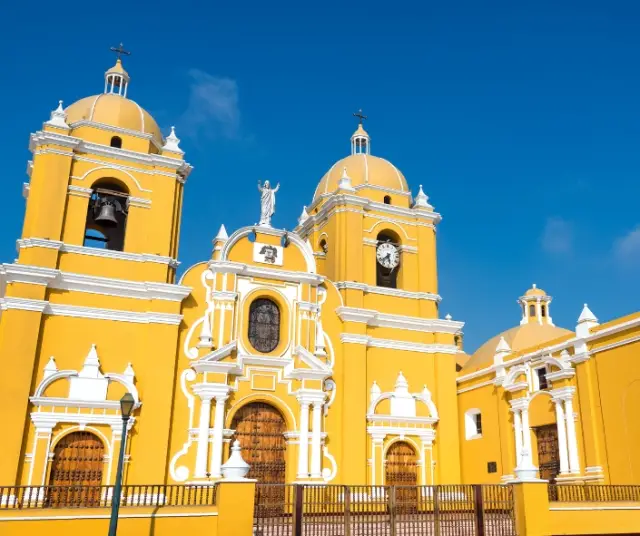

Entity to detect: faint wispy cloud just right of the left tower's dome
[178,69,240,139]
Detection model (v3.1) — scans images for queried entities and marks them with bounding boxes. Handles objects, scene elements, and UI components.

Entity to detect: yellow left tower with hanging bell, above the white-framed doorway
[0,52,192,484]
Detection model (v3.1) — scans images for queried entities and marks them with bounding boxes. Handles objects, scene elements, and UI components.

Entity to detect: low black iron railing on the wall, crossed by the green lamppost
[0,485,216,509]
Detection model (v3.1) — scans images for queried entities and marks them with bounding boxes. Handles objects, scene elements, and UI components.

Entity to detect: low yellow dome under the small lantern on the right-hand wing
[462,322,574,373]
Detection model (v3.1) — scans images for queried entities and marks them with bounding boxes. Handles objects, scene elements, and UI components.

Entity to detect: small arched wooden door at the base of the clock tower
[385,441,418,512]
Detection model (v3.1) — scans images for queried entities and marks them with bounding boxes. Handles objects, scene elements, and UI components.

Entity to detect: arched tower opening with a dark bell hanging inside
[83,179,129,251]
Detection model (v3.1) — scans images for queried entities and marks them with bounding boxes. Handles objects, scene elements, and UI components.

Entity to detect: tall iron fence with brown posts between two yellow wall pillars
[254,484,515,536]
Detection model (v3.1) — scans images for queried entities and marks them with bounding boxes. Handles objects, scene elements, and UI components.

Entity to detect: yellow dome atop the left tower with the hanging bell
[65,93,162,145]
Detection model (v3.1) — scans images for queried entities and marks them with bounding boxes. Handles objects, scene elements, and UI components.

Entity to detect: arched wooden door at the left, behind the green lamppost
[47,432,104,507]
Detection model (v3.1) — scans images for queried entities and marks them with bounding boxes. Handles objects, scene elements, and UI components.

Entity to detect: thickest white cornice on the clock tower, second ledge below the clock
[336,307,464,334]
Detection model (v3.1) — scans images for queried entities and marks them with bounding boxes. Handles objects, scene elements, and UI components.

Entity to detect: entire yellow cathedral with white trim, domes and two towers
[0,55,640,500]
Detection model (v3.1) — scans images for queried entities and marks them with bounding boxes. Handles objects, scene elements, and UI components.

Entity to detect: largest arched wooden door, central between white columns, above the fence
[231,402,287,484]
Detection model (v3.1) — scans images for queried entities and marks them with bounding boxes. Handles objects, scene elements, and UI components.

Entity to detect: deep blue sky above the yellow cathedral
[0,0,640,351]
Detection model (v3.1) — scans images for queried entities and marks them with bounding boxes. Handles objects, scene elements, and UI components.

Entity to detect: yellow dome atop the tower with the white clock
[313,153,409,201]
